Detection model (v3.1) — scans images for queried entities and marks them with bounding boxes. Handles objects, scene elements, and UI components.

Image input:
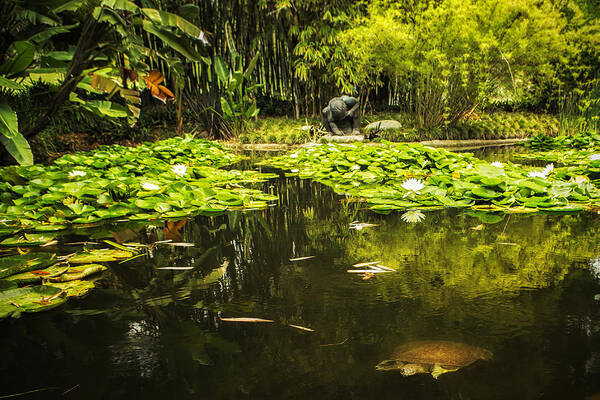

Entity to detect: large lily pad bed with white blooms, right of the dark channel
[262,143,600,213]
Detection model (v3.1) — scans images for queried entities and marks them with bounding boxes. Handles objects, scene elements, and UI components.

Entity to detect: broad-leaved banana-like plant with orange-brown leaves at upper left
[0,0,208,163]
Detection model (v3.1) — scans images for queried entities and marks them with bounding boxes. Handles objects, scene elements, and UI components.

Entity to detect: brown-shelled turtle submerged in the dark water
[375,340,492,379]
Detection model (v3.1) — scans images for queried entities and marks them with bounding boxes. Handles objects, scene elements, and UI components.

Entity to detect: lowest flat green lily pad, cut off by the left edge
[0,285,66,318]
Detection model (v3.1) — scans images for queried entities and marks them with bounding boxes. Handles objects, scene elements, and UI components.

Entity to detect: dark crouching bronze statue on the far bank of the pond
[322,96,360,136]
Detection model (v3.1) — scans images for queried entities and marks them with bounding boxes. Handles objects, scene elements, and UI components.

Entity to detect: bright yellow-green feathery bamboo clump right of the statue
[340,0,568,127]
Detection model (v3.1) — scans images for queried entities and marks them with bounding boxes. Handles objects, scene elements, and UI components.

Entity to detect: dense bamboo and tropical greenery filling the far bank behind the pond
[0,0,600,164]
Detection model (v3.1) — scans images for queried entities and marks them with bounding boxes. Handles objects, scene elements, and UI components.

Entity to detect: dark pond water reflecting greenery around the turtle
[0,148,600,399]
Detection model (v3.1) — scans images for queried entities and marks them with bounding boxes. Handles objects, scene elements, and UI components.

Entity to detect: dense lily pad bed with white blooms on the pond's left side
[0,136,276,231]
